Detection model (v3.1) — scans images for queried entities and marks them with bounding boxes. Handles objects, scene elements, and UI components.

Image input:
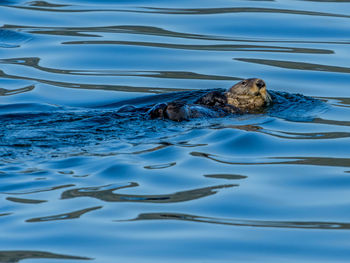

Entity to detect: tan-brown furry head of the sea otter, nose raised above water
[225,79,271,112]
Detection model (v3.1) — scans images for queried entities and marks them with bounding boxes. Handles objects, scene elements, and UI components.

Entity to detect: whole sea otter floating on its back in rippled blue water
[149,78,272,121]
